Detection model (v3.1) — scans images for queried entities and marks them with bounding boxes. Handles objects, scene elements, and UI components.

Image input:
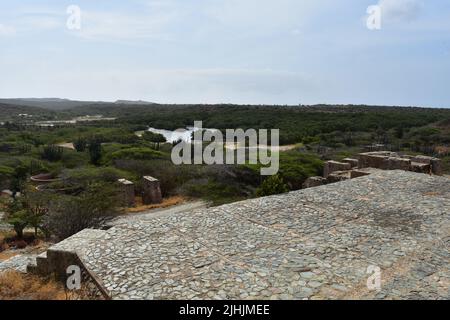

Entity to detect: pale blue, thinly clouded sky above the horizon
[0,0,450,107]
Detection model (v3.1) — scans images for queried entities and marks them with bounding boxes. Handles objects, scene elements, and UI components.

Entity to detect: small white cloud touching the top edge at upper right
[378,0,423,22]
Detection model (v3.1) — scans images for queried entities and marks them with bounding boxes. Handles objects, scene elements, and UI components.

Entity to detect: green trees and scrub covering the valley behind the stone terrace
[0,102,450,238]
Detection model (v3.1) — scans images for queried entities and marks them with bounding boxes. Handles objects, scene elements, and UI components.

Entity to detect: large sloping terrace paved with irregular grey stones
[44,171,450,299]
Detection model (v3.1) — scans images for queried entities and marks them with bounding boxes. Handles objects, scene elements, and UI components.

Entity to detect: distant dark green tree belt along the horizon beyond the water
[59,104,450,144]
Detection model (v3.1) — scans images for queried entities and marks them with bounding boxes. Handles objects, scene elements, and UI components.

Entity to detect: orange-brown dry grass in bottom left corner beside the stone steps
[0,271,67,300]
